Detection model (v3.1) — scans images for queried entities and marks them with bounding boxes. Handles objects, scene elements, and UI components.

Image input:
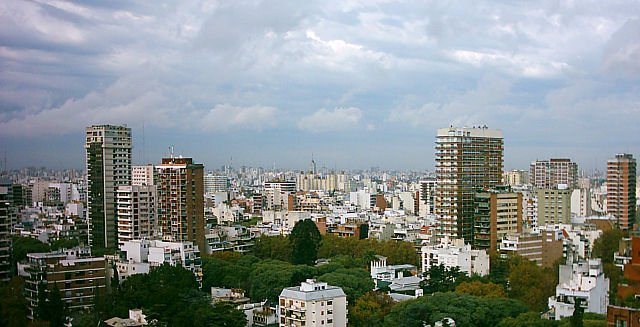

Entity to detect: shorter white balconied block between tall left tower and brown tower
[117,185,157,246]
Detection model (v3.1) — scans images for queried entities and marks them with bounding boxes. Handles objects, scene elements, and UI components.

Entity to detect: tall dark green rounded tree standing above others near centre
[289,219,322,265]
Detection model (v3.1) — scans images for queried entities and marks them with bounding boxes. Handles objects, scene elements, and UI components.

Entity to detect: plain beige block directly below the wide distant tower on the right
[537,189,571,226]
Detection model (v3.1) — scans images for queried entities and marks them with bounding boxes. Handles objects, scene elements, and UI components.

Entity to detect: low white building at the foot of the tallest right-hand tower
[422,237,489,276]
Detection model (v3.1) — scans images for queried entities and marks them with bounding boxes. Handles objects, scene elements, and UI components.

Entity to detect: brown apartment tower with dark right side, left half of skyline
[155,157,205,249]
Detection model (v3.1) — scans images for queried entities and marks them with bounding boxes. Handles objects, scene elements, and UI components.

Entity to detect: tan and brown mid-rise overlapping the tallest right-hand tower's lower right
[473,188,523,250]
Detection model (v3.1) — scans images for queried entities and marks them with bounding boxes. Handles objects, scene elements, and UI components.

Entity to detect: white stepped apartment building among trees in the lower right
[549,259,609,320]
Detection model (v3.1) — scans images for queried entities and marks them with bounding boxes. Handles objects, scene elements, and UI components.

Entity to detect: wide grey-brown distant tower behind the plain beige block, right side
[531,159,578,189]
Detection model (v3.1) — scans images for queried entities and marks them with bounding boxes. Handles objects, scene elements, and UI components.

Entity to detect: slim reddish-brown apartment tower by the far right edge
[607,153,636,229]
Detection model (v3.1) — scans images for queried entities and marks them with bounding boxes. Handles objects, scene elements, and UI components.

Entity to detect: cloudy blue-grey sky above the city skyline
[0,0,640,170]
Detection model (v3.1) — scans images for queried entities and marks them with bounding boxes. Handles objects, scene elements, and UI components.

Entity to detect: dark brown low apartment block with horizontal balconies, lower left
[24,248,107,319]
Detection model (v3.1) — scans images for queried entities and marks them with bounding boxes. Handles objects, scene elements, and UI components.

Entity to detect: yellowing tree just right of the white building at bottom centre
[349,291,394,327]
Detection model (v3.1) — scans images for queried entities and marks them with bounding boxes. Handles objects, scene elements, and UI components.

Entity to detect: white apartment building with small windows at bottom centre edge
[278,279,347,327]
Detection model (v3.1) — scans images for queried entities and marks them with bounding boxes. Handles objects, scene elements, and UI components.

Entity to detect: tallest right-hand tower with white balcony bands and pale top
[435,126,504,243]
